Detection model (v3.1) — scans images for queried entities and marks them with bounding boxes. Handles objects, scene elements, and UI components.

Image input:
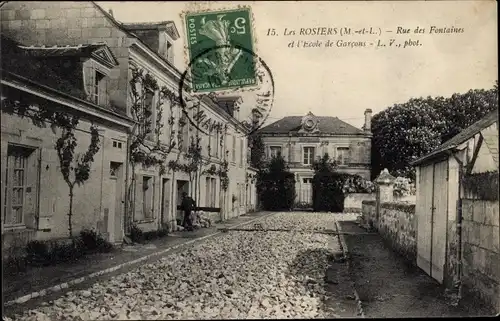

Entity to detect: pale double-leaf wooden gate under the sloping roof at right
[415,161,448,283]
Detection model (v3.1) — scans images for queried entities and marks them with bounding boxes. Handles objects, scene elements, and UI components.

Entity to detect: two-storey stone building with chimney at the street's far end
[259,109,372,203]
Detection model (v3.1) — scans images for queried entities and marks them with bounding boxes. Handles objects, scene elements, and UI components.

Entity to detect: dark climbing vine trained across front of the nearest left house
[2,90,99,239]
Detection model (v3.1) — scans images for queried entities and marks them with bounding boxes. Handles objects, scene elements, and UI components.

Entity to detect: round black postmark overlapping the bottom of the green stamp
[179,44,275,135]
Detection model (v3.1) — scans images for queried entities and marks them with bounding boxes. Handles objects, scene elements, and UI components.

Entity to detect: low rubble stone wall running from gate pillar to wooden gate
[361,201,417,264]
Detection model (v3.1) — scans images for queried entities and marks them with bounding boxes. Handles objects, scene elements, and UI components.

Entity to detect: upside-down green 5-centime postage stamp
[184,7,257,93]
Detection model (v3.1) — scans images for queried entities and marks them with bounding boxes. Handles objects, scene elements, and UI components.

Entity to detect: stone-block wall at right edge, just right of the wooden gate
[462,199,500,313]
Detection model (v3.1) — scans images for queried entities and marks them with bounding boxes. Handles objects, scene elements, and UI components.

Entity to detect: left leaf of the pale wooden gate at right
[415,164,434,275]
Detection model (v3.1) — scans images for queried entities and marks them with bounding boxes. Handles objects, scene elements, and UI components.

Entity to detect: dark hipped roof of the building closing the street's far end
[259,116,364,135]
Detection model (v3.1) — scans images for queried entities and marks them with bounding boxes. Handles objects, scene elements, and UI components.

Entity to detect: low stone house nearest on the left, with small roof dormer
[0,37,133,248]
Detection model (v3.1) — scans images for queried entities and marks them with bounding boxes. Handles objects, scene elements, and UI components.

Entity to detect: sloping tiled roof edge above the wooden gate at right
[412,109,498,165]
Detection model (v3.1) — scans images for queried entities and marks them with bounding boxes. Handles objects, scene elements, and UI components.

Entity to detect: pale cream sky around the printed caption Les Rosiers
[97,1,498,127]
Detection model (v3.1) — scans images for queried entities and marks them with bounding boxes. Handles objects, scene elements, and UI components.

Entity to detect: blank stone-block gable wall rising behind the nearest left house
[0,1,129,114]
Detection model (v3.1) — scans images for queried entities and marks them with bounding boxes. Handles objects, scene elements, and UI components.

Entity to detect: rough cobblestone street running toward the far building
[2,212,355,320]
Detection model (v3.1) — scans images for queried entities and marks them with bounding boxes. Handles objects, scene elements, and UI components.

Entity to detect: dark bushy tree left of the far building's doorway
[257,156,296,211]
